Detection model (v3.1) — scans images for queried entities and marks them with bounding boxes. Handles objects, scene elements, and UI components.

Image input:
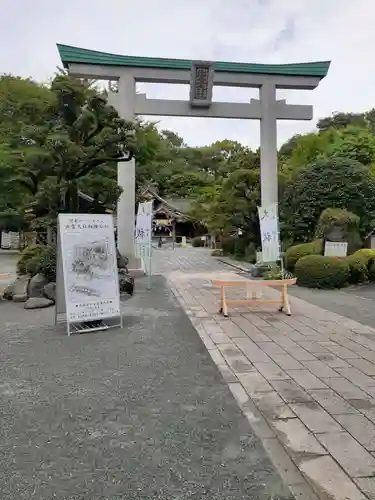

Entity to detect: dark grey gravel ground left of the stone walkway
[0,277,292,500]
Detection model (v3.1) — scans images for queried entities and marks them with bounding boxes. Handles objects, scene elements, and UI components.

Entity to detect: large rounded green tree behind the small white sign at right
[280,157,375,242]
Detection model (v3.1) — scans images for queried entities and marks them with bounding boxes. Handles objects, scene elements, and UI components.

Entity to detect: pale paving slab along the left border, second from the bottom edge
[273,418,327,457]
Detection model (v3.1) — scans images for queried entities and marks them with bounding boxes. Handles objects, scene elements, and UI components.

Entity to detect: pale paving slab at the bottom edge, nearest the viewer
[302,456,366,500]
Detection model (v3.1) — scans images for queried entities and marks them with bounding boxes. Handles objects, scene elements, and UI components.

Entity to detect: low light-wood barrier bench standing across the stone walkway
[212,278,296,318]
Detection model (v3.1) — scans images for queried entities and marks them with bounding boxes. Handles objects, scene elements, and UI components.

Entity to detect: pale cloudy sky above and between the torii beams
[0,0,375,148]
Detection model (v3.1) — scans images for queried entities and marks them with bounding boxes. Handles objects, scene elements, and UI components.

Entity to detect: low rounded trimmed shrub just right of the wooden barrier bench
[294,255,349,289]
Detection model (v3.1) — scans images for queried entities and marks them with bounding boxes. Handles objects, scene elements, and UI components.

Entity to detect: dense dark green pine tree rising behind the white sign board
[12,74,135,212]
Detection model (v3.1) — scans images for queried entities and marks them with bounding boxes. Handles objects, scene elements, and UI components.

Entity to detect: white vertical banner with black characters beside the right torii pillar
[258,203,280,262]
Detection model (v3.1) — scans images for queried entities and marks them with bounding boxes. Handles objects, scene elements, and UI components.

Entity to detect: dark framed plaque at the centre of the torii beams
[190,61,214,108]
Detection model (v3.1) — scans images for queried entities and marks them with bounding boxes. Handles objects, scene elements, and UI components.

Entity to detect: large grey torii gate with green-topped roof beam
[57,44,330,268]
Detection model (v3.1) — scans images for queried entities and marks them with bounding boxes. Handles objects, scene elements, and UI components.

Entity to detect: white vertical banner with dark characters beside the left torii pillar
[135,200,153,288]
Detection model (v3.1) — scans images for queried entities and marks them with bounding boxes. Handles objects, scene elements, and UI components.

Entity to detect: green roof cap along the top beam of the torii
[57,43,331,78]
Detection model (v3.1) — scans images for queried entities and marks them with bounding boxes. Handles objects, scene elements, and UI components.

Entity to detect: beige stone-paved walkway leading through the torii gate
[155,249,375,500]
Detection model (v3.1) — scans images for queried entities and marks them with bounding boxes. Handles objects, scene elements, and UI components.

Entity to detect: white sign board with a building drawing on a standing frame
[55,214,123,336]
